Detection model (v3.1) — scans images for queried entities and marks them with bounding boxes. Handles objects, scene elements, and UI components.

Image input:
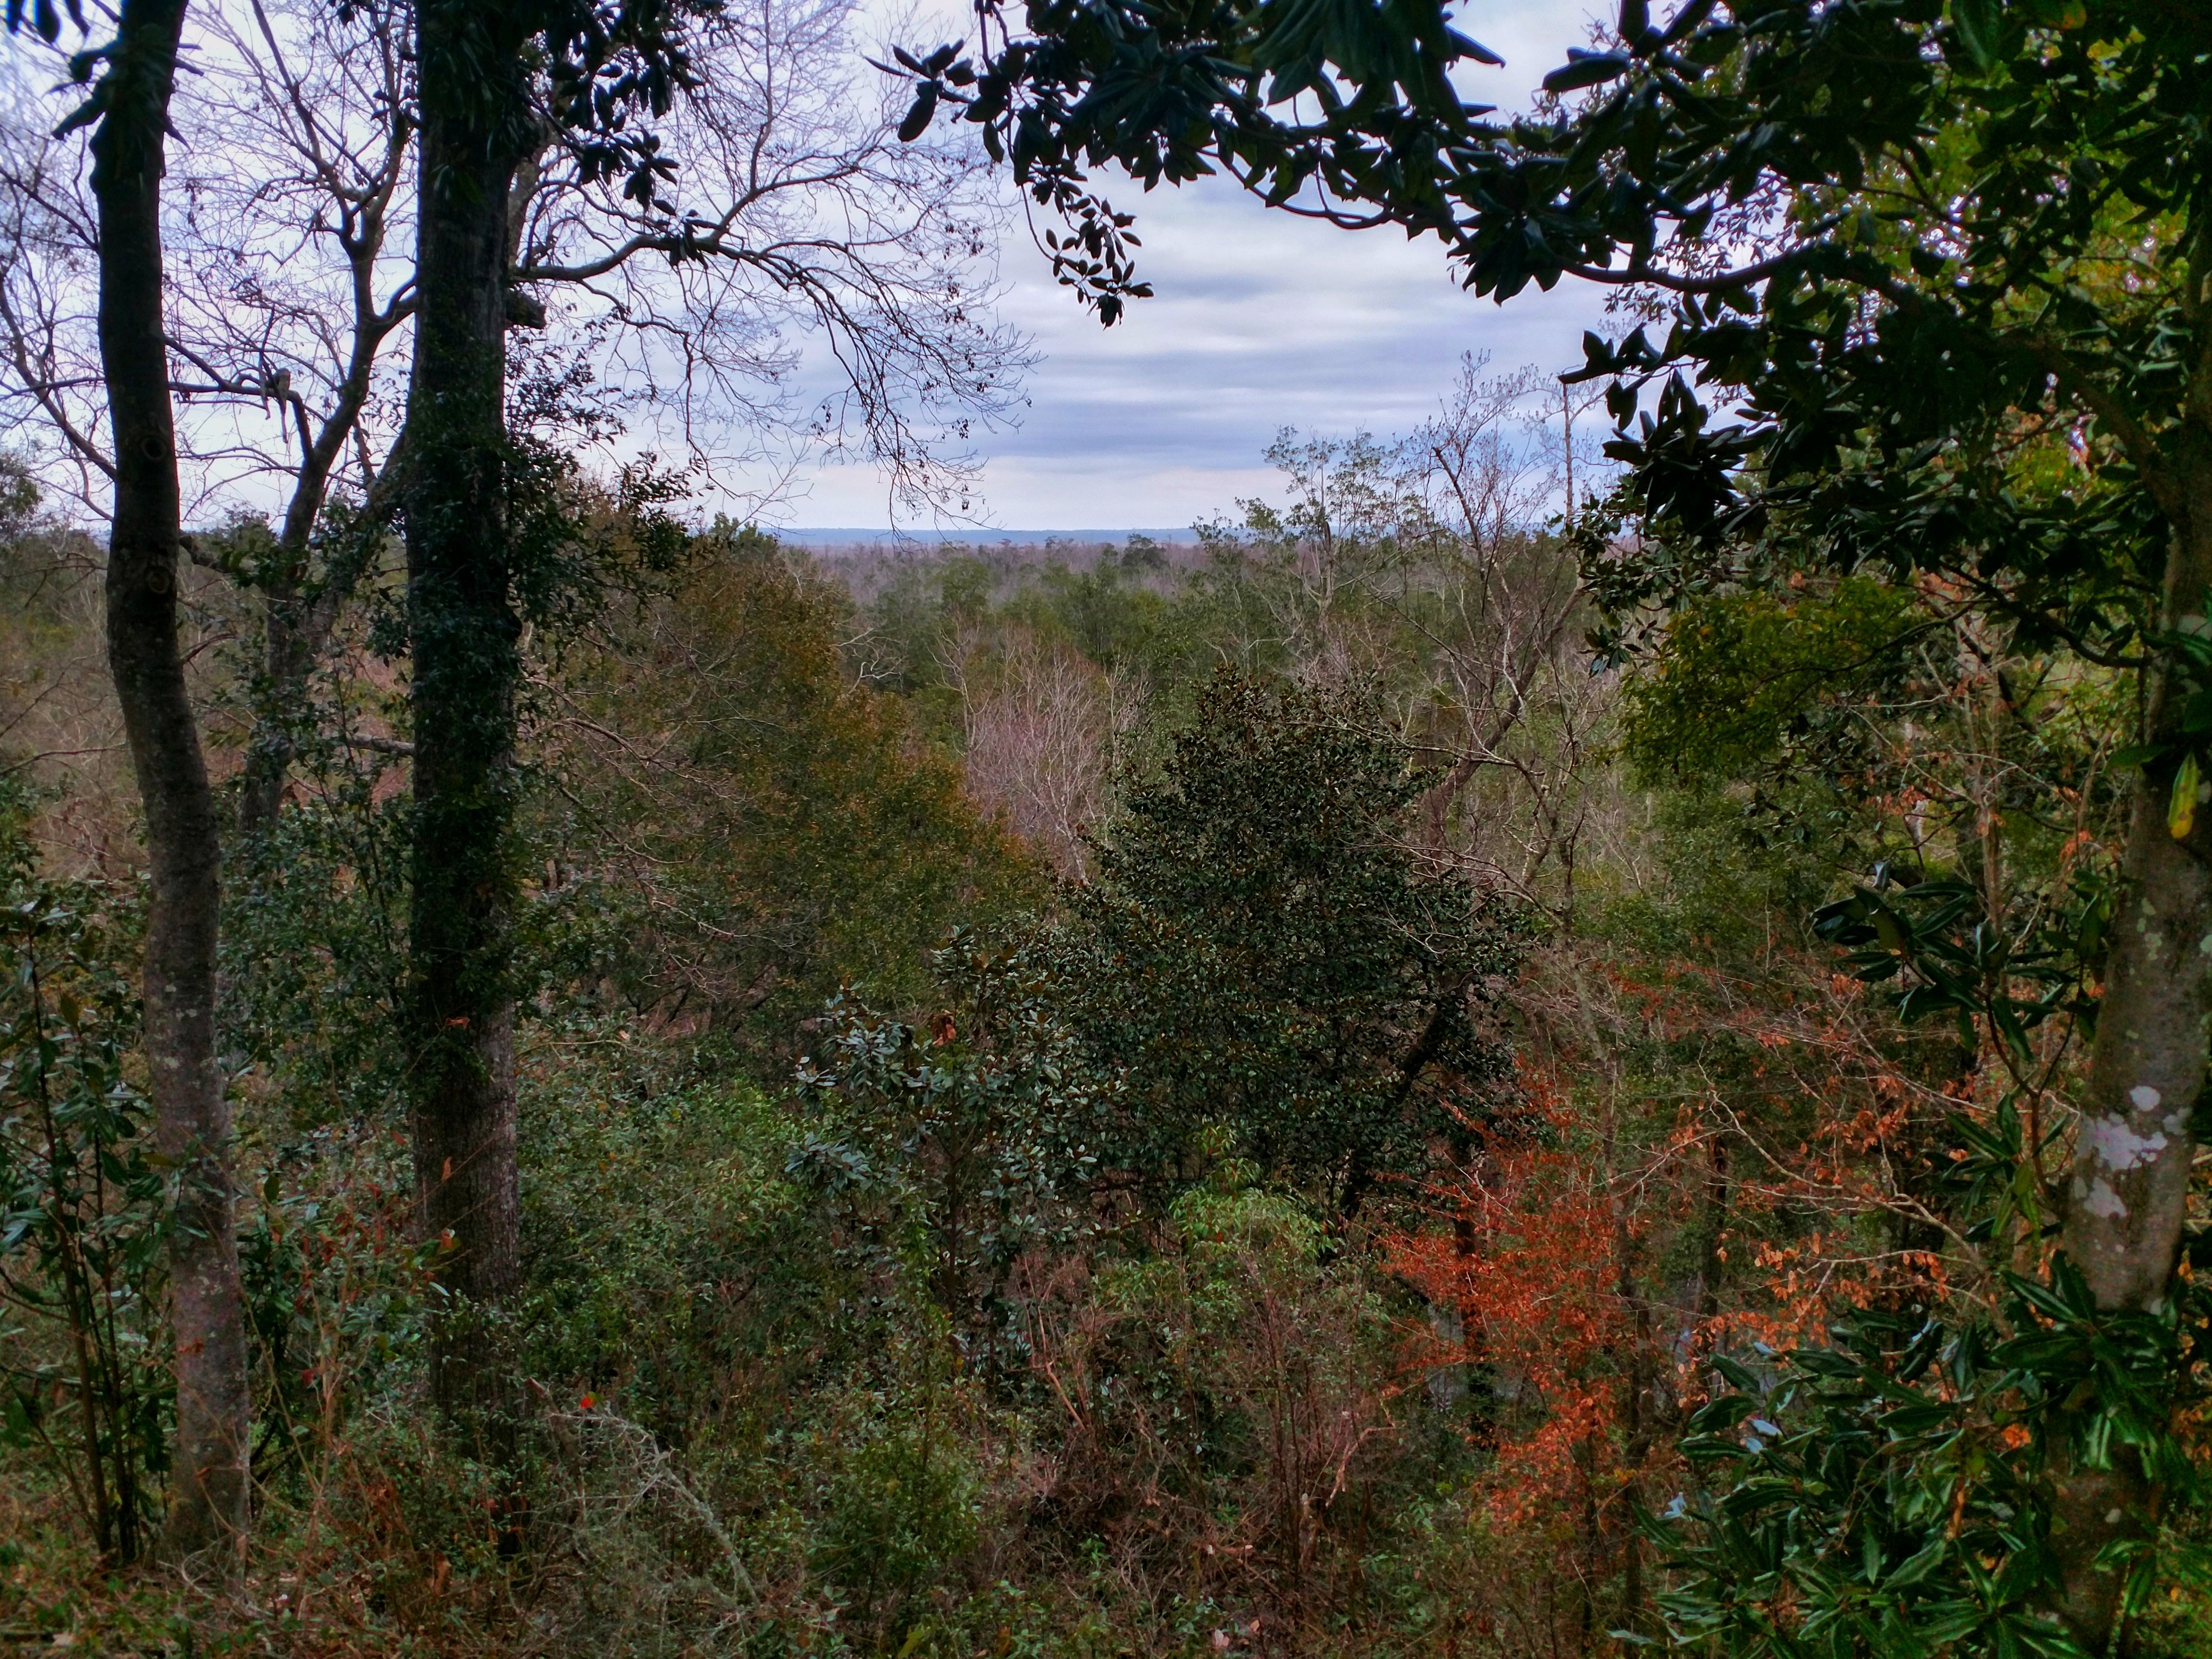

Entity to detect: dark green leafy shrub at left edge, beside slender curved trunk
[0,778,172,1564]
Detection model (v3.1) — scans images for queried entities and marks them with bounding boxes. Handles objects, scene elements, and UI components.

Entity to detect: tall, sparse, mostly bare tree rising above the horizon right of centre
[1205,367,1610,925]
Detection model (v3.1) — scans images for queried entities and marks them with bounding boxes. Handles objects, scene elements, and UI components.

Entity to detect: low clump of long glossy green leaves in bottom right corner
[1655,1256,2212,1659]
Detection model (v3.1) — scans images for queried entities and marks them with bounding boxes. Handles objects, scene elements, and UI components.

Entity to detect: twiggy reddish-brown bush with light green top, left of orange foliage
[1028,1161,1407,1626]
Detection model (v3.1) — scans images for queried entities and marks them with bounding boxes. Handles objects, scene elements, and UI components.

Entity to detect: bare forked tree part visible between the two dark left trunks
[170,0,414,839]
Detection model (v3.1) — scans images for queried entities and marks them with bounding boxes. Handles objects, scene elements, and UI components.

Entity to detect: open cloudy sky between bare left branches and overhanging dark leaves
[772,0,1610,531]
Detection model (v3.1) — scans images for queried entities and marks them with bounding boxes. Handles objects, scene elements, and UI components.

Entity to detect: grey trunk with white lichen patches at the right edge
[2052,510,2212,1653]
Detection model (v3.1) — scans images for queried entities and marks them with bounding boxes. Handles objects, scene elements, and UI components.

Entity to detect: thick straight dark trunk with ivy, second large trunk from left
[403,0,529,1413]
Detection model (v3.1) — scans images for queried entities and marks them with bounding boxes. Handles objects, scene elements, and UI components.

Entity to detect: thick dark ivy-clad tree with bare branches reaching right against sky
[398,0,1020,1402]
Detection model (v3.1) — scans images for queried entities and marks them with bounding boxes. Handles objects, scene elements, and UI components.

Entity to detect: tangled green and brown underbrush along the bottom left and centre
[0,1024,1480,1659]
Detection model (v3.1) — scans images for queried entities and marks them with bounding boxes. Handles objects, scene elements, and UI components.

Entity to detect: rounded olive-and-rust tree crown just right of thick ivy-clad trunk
[538,529,1035,1057]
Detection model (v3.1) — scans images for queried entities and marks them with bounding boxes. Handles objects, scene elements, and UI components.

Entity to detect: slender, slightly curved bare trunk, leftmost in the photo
[93,0,248,1553]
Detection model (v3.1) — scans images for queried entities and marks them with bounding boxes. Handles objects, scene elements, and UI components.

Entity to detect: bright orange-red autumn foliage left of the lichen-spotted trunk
[1389,929,2008,1650]
